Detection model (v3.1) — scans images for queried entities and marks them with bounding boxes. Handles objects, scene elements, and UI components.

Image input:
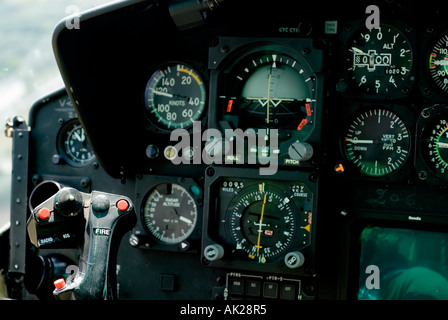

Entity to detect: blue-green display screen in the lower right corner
[358,226,448,300]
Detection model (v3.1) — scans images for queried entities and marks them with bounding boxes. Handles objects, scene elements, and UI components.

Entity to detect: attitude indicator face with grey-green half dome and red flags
[220,51,315,138]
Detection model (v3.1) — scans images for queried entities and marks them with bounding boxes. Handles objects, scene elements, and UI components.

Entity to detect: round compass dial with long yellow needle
[226,183,299,263]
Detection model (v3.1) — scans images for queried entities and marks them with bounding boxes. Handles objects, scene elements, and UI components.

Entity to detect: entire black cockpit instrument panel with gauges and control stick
[2,0,448,304]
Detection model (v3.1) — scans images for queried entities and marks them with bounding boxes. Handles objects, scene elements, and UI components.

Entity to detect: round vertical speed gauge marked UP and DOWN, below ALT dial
[343,108,411,177]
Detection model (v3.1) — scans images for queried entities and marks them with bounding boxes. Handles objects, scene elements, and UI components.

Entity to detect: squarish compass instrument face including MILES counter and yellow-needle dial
[215,178,313,263]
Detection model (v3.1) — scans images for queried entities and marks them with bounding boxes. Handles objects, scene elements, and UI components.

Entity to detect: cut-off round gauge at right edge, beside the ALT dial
[428,34,448,93]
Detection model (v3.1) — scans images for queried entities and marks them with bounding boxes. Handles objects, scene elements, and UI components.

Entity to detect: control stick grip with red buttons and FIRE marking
[28,188,134,300]
